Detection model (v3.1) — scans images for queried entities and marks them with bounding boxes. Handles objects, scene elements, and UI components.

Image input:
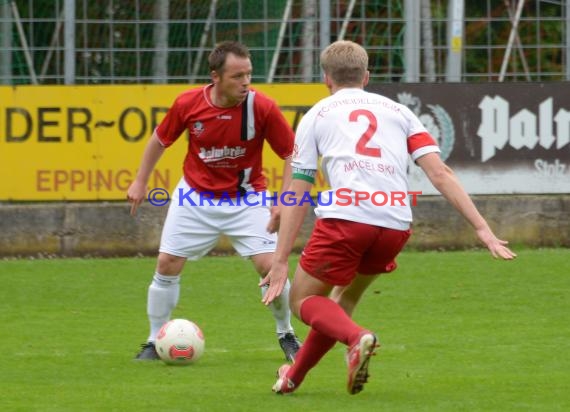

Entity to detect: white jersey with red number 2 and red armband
[292,88,440,230]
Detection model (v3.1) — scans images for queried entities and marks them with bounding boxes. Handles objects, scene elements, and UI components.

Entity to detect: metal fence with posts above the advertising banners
[0,0,570,85]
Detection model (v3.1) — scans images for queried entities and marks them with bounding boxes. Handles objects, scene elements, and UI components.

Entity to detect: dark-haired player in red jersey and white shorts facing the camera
[127,41,300,361]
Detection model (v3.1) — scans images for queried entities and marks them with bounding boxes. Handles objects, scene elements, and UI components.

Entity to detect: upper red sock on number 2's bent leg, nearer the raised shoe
[299,296,365,346]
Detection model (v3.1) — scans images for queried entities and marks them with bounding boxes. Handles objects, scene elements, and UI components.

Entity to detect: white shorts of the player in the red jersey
[159,178,277,260]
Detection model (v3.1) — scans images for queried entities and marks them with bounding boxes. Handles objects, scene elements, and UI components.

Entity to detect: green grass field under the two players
[0,249,570,412]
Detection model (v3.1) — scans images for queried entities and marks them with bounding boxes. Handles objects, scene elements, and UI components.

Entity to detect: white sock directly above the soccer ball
[146,272,180,342]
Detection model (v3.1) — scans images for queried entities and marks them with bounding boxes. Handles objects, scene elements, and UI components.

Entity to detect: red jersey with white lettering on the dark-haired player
[156,84,295,197]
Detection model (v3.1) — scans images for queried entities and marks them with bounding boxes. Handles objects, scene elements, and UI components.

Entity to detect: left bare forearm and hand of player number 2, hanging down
[259,179,313,305]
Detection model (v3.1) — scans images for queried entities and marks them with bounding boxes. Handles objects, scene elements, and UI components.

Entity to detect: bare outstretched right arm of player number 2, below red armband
[416,153,517,260]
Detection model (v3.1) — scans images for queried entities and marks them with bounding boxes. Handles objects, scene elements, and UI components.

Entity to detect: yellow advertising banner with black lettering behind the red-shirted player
[0,84,328,201]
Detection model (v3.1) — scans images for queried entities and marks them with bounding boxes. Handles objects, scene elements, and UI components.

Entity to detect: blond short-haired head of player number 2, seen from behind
[321,40,368,86]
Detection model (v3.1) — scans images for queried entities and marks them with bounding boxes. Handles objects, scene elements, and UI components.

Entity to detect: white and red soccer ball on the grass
[155,319,204,365]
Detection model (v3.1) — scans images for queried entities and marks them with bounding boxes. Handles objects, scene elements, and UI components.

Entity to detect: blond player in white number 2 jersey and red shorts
[261,41,516,394]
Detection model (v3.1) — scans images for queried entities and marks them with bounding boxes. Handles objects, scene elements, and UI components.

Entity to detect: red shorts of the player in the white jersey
[299,218,412,286]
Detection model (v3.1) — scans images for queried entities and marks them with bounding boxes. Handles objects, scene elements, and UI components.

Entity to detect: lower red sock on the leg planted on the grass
[287,329,336,387]
